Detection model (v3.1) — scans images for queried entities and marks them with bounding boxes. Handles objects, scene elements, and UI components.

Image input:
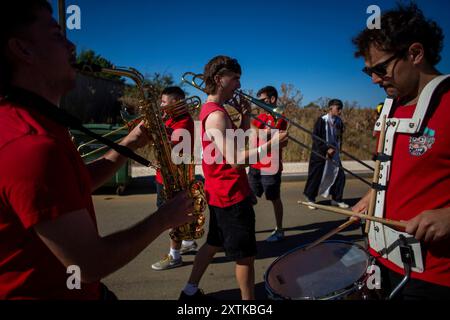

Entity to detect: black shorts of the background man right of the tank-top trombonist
[248,167,281,201]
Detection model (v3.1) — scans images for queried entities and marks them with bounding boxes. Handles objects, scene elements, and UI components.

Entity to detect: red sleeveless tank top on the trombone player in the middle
[200,102,250,208]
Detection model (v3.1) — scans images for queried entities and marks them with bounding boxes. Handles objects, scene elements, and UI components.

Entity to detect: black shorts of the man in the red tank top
[206,198,256,261]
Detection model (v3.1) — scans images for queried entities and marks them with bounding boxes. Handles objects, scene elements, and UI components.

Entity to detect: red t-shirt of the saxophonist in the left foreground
[0,101,100,300]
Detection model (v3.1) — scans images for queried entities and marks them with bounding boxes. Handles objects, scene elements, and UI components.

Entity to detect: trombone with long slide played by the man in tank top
[181,72,375,187]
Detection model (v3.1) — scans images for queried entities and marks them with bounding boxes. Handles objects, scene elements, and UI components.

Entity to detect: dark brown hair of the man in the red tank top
[203,56,242,94]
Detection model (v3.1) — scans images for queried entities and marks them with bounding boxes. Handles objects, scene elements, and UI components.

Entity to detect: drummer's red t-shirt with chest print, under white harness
[371,92,450,287]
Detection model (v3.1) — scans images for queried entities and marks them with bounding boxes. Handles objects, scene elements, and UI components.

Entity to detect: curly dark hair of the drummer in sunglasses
[352,2,444,66]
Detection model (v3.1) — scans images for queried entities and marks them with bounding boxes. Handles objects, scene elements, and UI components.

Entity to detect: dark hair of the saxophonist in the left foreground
[0,0,52,94]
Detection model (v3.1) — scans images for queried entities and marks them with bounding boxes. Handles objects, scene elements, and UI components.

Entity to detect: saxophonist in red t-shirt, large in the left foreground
[0,0,193,300]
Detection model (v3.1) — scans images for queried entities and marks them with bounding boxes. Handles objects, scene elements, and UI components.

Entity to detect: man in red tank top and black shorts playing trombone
[180,56,287,301]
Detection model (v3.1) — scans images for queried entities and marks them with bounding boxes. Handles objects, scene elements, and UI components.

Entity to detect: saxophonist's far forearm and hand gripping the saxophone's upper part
[86,122,148,191]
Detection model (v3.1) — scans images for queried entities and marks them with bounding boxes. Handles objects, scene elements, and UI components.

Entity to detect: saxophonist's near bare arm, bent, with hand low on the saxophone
[34,192,192,282]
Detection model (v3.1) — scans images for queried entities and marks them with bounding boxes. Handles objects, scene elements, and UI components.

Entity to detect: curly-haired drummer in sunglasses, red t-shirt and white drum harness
[353,4,450,300]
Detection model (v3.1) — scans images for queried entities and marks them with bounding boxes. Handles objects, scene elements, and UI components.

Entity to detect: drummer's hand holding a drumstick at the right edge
[406,208,450,243]
